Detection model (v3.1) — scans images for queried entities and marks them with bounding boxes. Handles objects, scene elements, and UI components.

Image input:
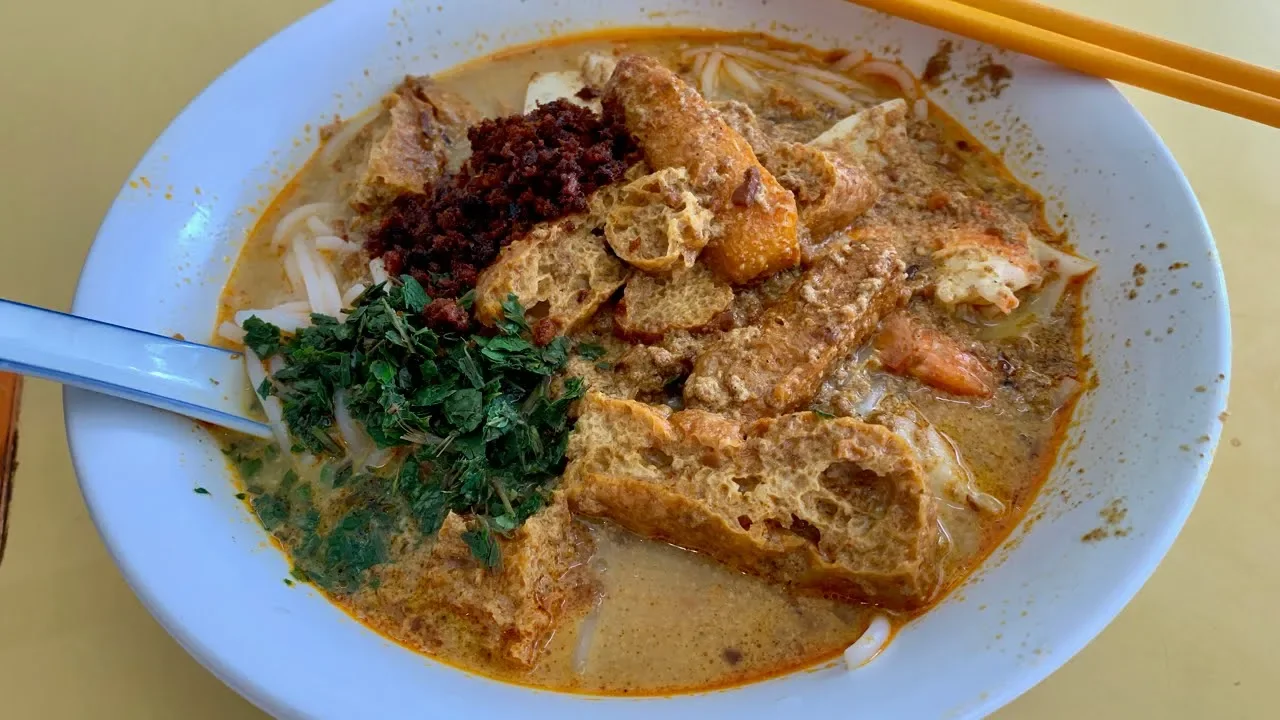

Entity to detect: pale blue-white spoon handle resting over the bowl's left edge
[0,300,271,438]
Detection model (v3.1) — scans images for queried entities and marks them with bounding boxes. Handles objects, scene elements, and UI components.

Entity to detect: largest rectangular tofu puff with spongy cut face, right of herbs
[564,393,940,610]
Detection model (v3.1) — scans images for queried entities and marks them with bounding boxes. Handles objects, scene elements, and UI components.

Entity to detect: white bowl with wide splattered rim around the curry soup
[65,0,1230,719]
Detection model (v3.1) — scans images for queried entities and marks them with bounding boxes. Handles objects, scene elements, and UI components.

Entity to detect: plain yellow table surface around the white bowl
[0,0,1280,719]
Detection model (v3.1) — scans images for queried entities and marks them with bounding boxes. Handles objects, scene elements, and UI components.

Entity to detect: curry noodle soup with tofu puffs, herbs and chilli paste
[218,33,1093,694]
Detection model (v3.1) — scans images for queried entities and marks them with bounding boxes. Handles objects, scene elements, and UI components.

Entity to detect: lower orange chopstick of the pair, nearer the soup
[852,0,1280,127]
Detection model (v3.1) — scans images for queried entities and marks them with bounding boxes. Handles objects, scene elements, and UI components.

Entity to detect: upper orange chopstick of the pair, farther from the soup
[956,0,1280,97]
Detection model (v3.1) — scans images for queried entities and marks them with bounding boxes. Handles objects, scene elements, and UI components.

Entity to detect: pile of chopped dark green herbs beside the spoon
[244,283,586,568]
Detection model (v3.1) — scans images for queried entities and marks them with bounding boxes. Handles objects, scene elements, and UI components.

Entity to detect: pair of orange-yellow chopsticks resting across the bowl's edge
[852,0,1280,127]
